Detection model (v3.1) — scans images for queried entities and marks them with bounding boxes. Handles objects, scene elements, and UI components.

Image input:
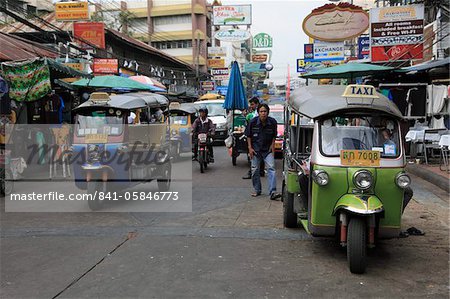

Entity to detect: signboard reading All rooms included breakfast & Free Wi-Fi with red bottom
[370,4,424,62]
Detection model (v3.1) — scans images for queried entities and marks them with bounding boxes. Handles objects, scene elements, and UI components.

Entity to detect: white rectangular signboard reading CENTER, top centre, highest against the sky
[213,5,252,26]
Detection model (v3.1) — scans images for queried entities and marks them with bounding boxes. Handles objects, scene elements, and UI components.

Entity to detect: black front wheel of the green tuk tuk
[347,217,367,274]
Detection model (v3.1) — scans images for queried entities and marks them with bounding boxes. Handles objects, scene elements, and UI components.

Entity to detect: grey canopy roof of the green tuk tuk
[289,85,403,119]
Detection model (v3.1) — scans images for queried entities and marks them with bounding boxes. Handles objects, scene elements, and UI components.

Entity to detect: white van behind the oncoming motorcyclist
[194,100,228,141]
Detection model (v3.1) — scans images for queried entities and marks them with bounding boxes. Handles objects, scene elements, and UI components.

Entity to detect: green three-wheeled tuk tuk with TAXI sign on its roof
[283,85,412,273]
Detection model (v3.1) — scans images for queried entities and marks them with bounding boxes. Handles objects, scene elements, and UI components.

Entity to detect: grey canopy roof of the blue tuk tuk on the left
[75,92,169,110]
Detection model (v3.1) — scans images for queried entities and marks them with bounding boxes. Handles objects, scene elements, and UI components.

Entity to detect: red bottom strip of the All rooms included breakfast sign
[371,44,423,62]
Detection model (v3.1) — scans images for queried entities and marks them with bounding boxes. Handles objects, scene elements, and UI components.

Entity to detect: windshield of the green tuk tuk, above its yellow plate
[319,116,400,158]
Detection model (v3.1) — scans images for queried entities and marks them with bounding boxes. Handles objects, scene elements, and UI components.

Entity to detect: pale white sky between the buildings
[221,0,332,84]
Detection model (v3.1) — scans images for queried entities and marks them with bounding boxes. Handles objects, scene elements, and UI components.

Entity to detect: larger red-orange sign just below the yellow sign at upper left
[73,22,105,49]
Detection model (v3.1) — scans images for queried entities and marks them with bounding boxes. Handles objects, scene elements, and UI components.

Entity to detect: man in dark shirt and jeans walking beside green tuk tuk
[245,104,281,200]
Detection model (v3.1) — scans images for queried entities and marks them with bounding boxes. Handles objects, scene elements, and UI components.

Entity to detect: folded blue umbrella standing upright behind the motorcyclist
[223,61,248,110]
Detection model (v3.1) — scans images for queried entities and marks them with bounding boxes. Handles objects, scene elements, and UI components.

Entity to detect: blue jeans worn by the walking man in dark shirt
[252,153,277,194]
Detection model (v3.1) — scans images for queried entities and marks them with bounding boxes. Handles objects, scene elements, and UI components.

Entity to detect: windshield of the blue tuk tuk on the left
[76,111,124,136]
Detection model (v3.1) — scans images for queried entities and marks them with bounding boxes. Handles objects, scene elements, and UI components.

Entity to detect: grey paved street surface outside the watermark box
[0,146,449,298]
